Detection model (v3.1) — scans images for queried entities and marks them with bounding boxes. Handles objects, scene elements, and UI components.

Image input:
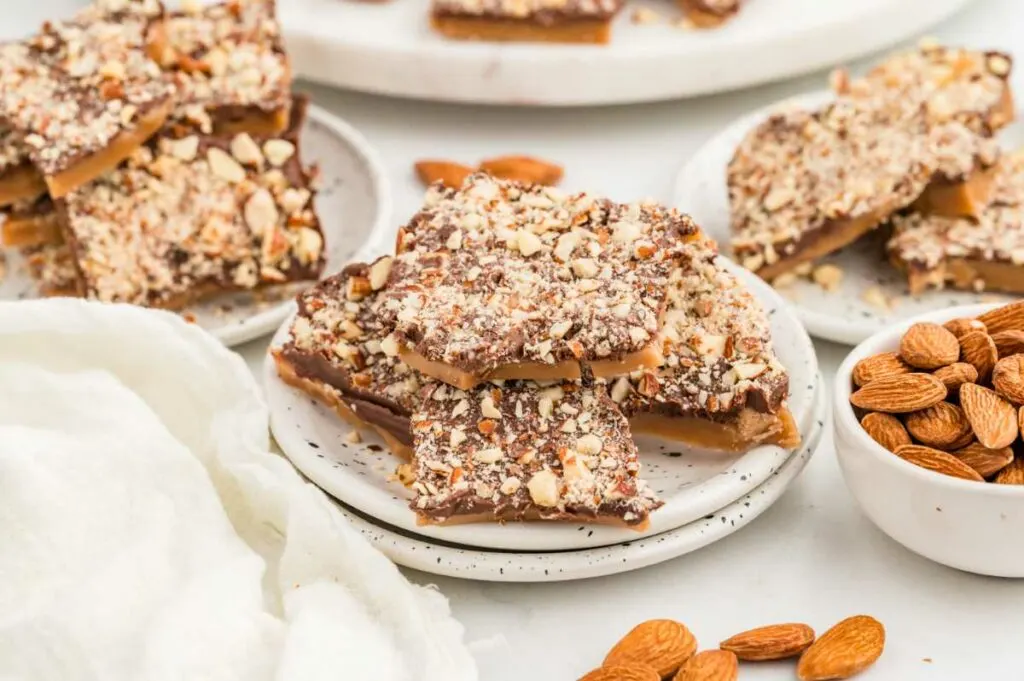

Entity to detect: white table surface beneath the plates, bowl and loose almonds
[234,0,1024,681]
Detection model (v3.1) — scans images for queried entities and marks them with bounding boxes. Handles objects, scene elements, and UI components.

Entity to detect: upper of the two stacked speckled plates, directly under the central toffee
[264,262,818,551]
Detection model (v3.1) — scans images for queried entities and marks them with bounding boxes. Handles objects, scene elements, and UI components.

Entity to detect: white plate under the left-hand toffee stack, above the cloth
[0,107,391,345]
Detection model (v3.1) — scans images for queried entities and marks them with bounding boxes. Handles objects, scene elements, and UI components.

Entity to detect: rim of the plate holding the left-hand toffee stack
[208,103,394,347]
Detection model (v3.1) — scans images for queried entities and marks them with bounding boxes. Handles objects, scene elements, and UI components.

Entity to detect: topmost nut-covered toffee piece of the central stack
[383,174,701,389]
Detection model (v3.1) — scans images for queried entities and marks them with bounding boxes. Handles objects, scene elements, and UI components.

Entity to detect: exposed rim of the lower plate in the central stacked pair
[325,391,831,584]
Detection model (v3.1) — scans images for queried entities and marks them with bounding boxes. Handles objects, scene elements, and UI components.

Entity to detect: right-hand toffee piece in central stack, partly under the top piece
[610,249,800,451]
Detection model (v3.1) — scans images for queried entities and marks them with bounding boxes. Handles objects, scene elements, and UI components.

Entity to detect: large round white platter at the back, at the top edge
[279,0,971,105]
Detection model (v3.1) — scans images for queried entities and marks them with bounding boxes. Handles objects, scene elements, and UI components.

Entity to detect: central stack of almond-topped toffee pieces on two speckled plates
[274,173,799,528]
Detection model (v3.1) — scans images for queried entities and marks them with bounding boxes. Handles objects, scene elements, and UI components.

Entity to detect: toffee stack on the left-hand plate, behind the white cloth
[0,0,324,309]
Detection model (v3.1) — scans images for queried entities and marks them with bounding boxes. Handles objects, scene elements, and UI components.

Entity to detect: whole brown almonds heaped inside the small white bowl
[850,301,1024,484]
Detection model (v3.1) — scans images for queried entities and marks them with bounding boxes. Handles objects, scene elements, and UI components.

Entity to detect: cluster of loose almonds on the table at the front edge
[580,614,886,681]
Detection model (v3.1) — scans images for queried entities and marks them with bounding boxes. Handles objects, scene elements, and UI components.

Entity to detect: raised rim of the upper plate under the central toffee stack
[262,256,822,550]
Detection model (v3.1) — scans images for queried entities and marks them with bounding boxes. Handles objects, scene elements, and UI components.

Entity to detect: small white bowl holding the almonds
[833,304,1024,578]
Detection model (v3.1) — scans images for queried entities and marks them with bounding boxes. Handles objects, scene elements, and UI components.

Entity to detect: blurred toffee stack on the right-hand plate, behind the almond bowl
[728,42,1024,294]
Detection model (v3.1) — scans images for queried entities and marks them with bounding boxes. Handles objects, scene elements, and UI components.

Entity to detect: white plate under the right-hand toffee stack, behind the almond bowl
[675,91,1024,345]
